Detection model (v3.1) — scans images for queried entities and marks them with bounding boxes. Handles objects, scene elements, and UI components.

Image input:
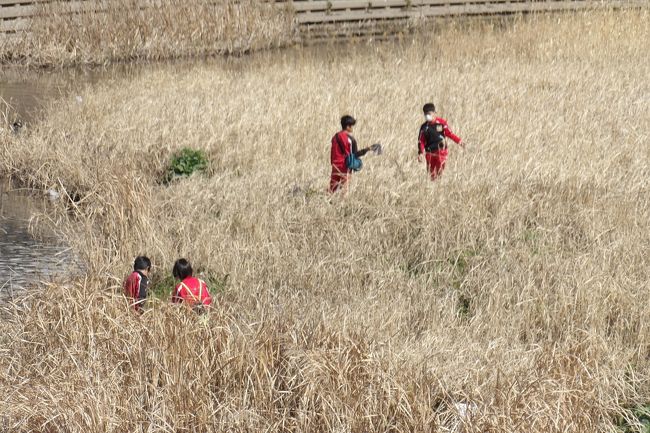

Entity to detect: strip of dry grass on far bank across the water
[0,0,295,66]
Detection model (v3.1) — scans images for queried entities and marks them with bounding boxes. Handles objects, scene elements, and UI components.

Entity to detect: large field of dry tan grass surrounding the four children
[0,12,650,432]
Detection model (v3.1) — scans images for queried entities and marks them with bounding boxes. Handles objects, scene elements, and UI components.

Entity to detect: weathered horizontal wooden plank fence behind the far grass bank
[0,0,650,32]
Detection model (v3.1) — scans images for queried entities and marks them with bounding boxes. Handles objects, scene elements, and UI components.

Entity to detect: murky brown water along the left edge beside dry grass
[0,67,109,292]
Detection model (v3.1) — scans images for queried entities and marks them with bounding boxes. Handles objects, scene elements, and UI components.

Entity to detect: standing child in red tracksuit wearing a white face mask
[418,103,465,180]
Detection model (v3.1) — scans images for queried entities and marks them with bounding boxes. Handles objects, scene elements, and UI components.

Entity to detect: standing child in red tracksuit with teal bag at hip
[329,115,381,192]
